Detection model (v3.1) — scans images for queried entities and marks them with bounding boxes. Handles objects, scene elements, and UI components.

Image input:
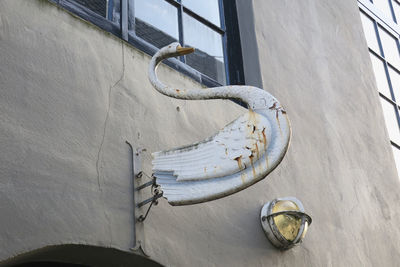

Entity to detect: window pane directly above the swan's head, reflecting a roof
[134,0,179,48]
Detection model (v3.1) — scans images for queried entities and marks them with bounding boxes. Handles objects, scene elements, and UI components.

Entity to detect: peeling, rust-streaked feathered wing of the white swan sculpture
[153,110,271,182]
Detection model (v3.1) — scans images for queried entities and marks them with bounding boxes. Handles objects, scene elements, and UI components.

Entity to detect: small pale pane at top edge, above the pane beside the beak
[182,0,221,26]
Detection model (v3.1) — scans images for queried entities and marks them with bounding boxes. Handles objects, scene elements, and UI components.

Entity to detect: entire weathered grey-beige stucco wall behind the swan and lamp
[0,0,400,266]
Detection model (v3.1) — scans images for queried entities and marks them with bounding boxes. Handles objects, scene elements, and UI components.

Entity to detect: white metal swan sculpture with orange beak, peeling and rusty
[149,43,291,205]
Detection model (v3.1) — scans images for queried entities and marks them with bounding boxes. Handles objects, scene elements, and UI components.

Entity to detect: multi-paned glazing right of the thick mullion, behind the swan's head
[130,0,226,84]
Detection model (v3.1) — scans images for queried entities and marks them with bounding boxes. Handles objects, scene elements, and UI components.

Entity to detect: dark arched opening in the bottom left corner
[0,244,162,267]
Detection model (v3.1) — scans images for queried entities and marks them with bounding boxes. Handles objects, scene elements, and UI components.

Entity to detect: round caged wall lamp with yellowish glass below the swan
[261,197,312,249]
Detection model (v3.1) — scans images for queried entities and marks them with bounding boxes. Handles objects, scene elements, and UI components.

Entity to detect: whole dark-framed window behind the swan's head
[51,0,244,86]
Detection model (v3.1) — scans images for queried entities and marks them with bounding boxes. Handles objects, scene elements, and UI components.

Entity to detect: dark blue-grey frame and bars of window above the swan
[48,0,245,87]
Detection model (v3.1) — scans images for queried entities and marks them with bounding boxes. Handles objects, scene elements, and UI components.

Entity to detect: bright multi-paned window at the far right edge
[358,0,400,174]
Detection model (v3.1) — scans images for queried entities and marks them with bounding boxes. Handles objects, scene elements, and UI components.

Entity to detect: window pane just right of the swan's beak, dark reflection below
[183,14,226,84]
